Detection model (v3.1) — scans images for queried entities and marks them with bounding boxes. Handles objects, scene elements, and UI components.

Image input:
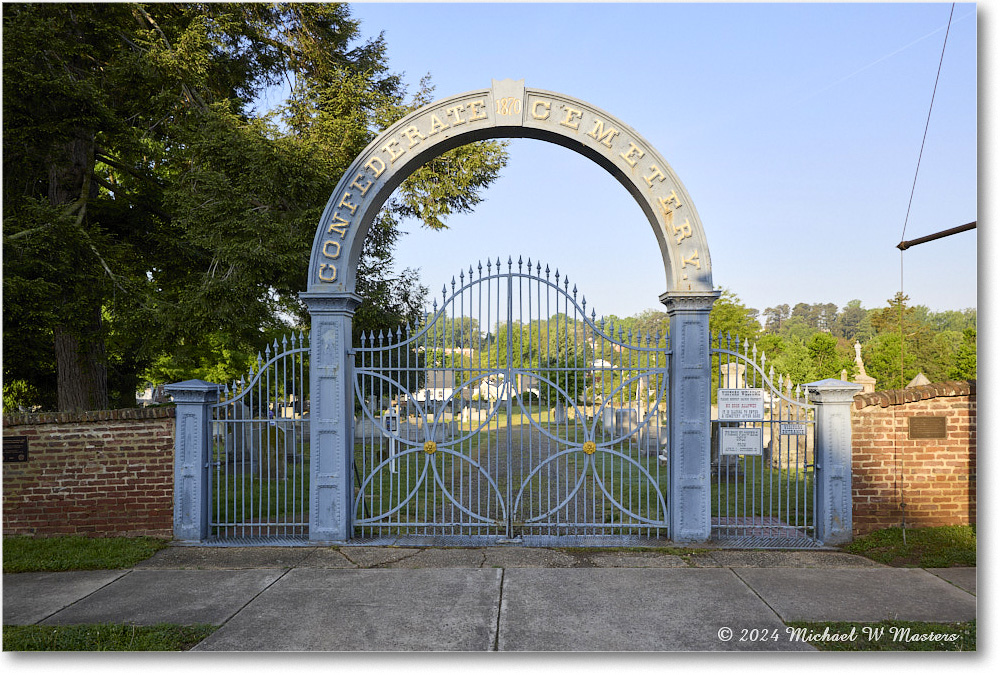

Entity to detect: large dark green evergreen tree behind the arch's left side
[3,3,506,409]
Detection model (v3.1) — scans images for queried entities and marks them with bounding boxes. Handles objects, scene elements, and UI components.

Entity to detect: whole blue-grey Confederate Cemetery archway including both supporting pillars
[301,79,718,541]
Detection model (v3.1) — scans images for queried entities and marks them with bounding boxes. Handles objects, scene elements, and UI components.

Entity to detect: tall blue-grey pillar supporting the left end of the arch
[299,293,361,542]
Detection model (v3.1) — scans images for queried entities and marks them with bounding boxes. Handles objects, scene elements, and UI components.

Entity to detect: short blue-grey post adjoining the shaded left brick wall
[163,380,222,542]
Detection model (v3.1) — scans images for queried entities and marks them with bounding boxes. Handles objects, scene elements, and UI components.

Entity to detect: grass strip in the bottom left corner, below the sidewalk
[3,623,217,652]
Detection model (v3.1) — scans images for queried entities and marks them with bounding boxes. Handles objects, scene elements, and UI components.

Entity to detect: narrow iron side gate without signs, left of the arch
[208,333,310,544]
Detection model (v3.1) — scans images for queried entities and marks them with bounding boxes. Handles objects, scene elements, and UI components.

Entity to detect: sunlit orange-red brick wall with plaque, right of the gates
[851,380,976,535]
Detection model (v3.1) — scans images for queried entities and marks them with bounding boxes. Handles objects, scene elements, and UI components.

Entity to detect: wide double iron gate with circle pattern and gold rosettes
[354,259,669,545]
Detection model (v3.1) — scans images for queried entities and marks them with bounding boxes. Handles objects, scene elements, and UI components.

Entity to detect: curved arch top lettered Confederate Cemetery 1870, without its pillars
[309,80,713,293]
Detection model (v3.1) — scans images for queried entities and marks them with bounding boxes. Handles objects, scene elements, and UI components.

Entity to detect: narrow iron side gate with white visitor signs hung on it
[710,334,820,548]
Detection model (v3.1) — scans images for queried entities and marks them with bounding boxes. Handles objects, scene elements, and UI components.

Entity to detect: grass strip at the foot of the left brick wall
[3,535,167,574]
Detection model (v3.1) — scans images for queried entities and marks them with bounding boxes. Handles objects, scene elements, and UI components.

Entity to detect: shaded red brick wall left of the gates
[3,407,175,537]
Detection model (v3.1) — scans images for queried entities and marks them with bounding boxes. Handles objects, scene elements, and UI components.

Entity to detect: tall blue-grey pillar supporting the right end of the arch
[660,291,721,542]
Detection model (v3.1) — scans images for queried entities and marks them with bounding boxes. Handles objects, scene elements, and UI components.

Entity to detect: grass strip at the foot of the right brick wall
[844,525,976,567]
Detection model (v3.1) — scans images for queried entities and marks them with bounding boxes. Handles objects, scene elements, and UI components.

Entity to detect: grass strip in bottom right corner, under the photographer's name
[787,621,976,652]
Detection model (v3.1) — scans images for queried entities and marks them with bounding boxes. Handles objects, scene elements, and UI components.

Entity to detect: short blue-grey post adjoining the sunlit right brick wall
[805,379,863,545]
